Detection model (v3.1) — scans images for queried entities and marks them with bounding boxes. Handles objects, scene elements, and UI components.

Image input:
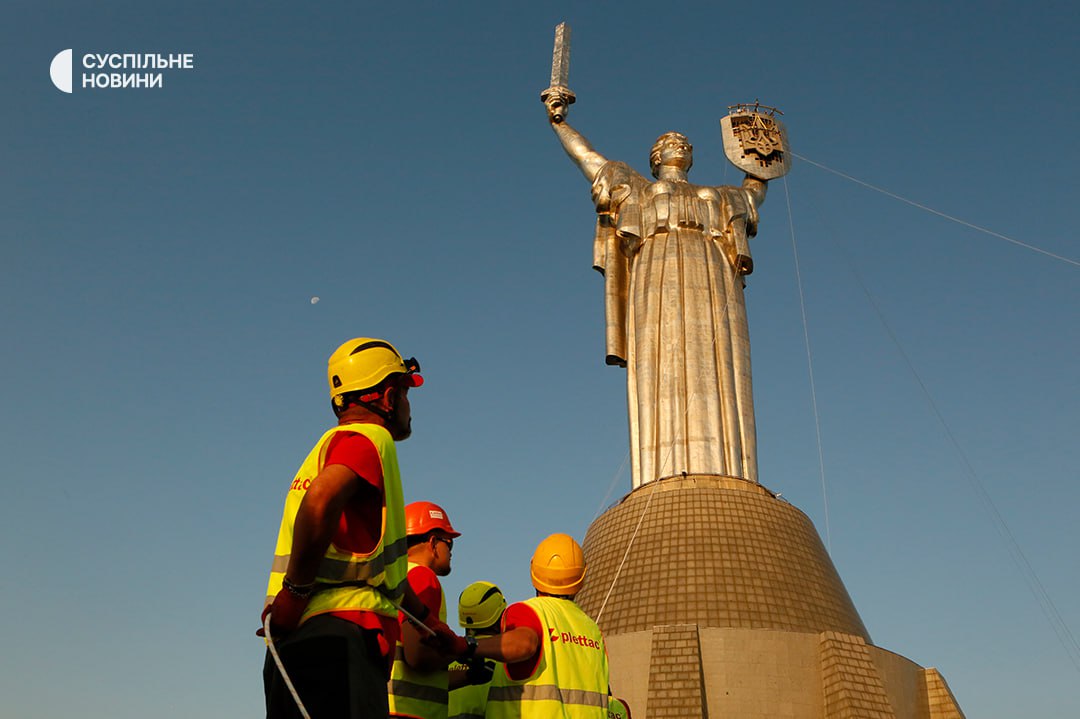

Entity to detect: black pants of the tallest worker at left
[262,615,390,719]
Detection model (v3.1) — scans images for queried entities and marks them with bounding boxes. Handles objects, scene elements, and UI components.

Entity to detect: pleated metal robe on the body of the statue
[593,162,757,488]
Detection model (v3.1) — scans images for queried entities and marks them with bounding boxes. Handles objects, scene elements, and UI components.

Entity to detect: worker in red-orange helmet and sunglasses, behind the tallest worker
[388,502,467,719]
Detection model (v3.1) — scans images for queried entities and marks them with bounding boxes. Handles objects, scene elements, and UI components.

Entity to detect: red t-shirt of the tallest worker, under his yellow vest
[325,432,401,657]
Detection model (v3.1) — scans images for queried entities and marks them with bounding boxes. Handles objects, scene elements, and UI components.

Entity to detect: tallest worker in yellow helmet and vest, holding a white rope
[259,337,460,719]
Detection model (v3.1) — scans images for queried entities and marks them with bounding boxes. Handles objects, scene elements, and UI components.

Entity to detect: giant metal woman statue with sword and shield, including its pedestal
[540,24,963,719]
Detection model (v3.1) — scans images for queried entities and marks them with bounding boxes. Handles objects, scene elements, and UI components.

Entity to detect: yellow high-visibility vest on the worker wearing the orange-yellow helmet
[487,597,608,719]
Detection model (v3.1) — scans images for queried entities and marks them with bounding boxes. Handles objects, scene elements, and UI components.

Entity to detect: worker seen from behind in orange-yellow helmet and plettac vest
[462,534,608,719]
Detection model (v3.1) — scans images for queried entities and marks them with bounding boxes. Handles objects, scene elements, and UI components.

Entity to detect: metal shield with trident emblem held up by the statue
[720,107,792,180]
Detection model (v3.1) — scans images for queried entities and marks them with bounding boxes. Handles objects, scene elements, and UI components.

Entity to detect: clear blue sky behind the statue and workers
[0,0,1080,719]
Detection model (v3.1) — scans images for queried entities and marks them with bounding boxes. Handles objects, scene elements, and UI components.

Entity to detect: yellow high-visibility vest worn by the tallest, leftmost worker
[267,422,408,622]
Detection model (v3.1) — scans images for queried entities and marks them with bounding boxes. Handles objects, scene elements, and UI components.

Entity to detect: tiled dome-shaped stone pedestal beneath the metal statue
[577,476,963,719]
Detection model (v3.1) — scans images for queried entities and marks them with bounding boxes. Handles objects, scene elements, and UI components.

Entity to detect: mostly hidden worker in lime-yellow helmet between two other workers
[449,582,507,719]
